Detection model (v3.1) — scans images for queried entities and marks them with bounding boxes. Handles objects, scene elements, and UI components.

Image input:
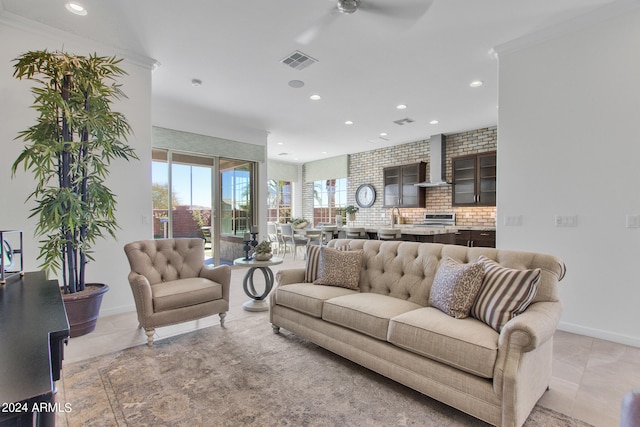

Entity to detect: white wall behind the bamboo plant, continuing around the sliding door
[0,17,267,316]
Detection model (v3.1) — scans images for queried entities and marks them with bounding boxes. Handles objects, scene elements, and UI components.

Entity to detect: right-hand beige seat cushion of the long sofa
[388,307,499,378]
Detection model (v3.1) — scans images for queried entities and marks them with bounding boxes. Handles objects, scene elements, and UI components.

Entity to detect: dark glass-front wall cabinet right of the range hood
[451,151,496,206]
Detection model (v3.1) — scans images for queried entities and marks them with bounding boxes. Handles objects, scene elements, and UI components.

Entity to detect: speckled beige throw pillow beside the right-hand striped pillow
[429,257,484,319]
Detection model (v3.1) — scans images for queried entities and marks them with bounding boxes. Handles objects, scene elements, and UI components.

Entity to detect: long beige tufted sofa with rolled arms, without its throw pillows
[270,239,565,426]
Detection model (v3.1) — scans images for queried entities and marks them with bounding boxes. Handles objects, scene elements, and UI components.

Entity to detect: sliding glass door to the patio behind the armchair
[152,150,256,265]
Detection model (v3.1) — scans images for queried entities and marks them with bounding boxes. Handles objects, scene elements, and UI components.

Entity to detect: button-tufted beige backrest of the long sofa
[328,239,565,307]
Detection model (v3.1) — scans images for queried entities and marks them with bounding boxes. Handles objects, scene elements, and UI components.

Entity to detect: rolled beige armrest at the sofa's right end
[498,301,562,352]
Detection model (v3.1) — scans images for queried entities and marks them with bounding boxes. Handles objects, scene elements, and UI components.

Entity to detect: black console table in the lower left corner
[0,272,69,427]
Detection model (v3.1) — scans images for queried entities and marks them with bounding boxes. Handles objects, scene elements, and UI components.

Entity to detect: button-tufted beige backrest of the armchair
[124,239,204,285]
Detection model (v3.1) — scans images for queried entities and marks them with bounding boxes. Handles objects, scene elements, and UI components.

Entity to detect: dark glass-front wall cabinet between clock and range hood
[382,162,426,208]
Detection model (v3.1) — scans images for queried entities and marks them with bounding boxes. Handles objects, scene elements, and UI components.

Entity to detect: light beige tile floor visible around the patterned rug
[64,254,640,427]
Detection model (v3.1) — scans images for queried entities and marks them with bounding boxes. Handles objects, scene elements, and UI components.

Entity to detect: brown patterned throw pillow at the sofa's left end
[313,247,362,289]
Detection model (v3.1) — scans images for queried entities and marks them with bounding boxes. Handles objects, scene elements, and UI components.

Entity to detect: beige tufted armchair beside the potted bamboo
[124,239,231,347]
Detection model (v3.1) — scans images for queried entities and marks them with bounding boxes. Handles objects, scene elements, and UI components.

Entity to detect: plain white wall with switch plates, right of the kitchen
[496,6,640,346]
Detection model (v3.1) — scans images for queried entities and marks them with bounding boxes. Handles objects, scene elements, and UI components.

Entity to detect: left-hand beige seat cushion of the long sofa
[275,283,357,317]
